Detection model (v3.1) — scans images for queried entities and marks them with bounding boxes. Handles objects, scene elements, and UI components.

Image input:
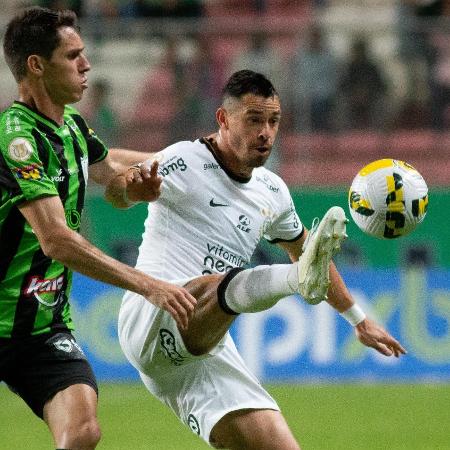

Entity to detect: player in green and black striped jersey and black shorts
[0,7,196,450]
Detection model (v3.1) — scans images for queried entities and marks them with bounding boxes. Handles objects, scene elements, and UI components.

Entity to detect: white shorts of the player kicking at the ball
[119,280,279,444]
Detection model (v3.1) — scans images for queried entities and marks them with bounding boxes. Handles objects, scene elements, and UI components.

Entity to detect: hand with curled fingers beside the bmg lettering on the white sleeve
[125,161,162,202]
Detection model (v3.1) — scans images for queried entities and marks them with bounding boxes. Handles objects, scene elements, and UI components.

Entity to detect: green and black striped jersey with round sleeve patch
[0,102,108,338]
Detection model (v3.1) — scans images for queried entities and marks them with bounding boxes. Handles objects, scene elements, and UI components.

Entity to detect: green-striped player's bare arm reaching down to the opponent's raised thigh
[19,196,196,328]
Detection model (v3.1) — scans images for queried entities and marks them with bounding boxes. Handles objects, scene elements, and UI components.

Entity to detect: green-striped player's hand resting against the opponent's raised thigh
[145,280,197,329]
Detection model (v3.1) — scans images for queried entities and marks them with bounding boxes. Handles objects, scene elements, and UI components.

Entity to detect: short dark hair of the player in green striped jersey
[3,6,79,81]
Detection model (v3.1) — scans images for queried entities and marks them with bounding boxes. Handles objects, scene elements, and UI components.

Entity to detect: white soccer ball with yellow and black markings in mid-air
[348,159,428,239]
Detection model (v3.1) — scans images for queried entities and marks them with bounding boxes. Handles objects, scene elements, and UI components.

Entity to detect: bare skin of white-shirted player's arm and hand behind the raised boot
[279,229,406,358]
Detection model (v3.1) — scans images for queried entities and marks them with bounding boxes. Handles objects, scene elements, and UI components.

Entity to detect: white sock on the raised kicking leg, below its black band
[224,263,298,313]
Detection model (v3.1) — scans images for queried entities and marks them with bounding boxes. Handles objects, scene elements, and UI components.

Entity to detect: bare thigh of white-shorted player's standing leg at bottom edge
[210,409,300,450]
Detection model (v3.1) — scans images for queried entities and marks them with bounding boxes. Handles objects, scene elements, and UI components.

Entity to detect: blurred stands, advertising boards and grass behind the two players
[0,0,450,450]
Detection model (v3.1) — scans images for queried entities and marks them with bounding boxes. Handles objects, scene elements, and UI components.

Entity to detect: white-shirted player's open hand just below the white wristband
[355,318,406,358]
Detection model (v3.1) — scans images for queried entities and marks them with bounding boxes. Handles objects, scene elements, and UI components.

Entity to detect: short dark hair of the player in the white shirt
[222,70,278,100]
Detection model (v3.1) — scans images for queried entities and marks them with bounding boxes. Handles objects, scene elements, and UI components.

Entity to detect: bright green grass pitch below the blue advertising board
[0,384,450,450]
